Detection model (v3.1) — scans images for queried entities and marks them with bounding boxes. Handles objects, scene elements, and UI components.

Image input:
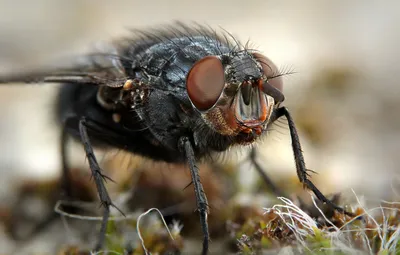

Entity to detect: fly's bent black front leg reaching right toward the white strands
[264,107,354,216]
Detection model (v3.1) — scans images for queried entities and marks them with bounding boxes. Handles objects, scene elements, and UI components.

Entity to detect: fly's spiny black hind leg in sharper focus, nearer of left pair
[79,117,124,251]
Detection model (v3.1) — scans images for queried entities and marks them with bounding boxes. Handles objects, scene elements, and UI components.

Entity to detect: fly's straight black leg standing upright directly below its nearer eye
[179,137,210,255]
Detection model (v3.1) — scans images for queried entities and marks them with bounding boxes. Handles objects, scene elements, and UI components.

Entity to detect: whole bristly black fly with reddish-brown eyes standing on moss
[0,24,352,254]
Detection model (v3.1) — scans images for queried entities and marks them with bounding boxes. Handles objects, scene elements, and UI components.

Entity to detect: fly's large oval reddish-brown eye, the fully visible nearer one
[186,56,225,111]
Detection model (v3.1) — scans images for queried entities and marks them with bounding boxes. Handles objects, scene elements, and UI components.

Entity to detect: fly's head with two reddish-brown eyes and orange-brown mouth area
[186,51,284,144]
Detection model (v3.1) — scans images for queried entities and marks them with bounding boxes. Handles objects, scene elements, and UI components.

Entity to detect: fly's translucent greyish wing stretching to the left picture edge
[0,40,127,87]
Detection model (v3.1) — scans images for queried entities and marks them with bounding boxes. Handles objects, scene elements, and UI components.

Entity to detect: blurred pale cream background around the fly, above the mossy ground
[0,0,400,253]
